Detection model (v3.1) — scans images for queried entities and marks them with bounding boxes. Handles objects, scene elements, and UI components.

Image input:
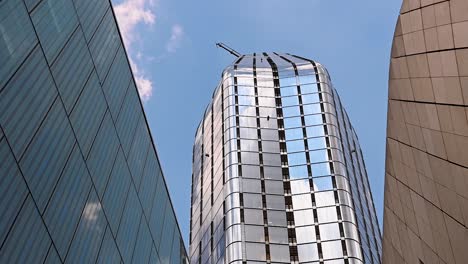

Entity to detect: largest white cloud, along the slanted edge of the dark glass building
[114,0,156,102]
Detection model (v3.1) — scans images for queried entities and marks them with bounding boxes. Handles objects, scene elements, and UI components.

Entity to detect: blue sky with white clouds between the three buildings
[113,0,401,244]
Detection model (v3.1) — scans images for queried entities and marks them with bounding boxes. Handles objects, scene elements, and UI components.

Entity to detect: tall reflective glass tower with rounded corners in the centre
[189,53,381,264]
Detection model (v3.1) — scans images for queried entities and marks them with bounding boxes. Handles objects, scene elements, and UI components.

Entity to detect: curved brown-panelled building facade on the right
[383,0,468,264]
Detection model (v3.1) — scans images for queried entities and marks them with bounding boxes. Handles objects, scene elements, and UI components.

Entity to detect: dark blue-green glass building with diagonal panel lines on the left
[0,0,185,264]
